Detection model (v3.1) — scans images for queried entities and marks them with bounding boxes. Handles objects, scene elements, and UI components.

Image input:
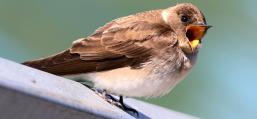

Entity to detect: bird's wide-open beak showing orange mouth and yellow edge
[186,23,212,50]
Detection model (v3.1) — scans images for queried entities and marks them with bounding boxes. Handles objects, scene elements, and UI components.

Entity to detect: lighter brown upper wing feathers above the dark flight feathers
[70,21,168,60]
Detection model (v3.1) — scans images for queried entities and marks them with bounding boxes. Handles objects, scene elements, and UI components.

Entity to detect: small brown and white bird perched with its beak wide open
[22,3,211,113]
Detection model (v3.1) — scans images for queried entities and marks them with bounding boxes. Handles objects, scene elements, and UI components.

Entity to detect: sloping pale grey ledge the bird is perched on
[0,58,196,119]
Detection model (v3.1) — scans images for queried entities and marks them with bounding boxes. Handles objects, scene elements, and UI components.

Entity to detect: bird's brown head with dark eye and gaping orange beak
[162,3,211,54]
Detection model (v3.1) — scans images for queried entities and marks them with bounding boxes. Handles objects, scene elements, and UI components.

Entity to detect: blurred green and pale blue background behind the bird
[0,0,257,119]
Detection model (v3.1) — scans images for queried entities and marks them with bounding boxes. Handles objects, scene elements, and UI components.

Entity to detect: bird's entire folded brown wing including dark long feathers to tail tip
[24,21,175,75]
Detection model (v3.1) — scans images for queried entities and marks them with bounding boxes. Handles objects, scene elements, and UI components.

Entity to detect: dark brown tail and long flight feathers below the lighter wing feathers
[22,50,134,76]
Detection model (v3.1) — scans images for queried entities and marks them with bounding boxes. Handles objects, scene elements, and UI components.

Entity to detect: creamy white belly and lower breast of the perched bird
[66,54,192,97]
